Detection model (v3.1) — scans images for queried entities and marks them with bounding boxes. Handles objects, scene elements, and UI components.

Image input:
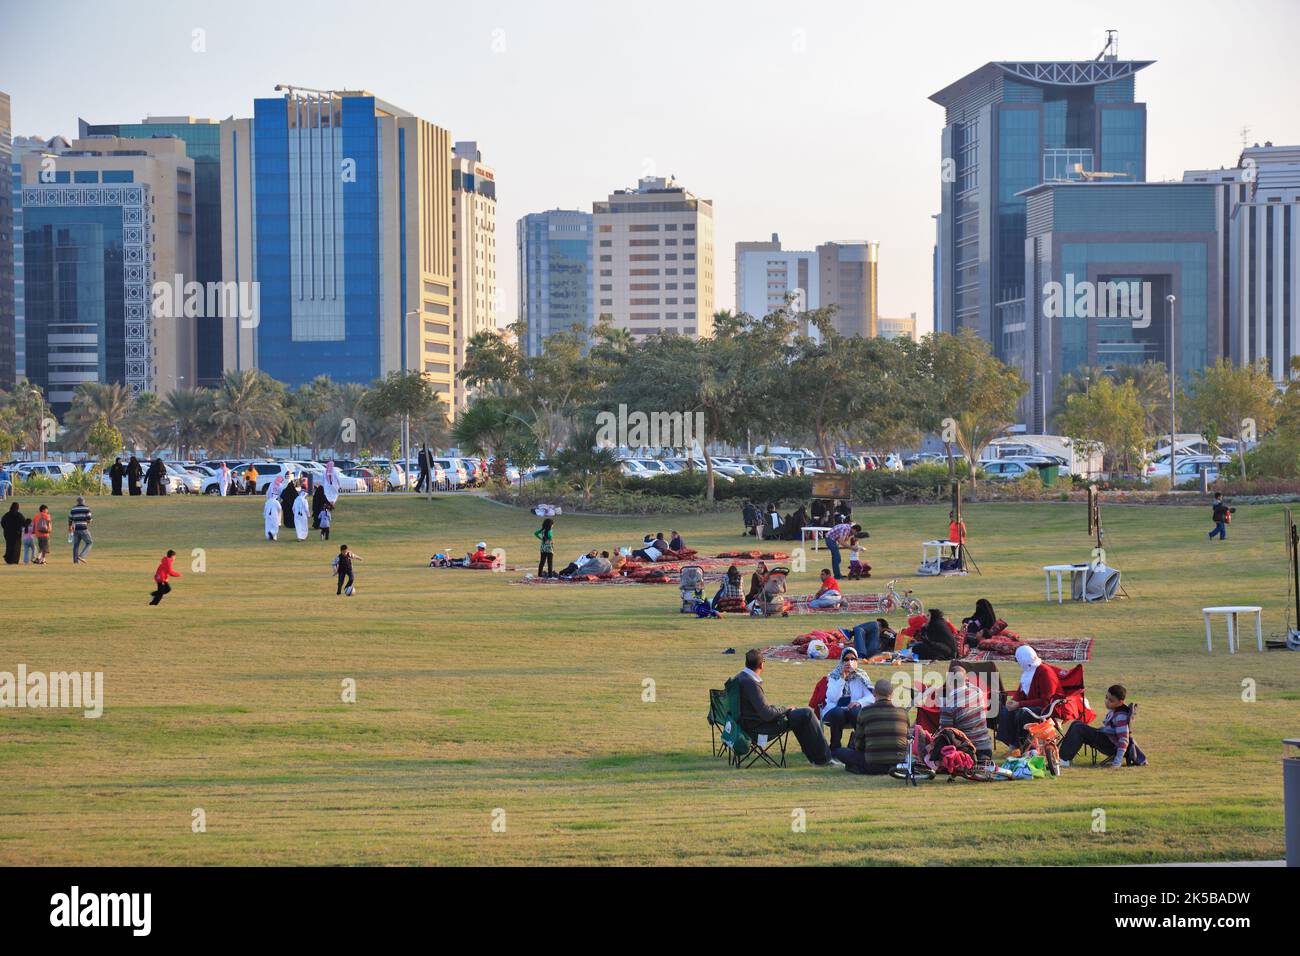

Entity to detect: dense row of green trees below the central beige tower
[454,310,1027,498]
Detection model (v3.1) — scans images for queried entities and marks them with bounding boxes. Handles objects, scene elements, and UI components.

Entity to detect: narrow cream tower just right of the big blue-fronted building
[451,140,497,408]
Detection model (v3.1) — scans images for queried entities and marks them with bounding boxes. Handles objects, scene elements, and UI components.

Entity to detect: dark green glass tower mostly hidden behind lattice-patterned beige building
[78,116,222,386]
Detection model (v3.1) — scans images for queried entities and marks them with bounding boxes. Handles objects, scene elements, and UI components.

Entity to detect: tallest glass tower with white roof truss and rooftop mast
[930,51,1152,374]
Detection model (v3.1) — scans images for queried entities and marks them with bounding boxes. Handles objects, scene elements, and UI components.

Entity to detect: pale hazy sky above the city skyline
[0,0,1300,330]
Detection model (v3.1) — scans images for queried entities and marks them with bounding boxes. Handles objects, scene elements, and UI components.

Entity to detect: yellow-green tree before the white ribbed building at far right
[1186,359,1278,480]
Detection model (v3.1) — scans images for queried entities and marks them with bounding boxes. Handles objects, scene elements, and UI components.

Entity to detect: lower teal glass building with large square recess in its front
[1019,182,1223,432]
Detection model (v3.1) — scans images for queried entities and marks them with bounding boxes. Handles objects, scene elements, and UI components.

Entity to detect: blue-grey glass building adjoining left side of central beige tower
[515,209,595,355]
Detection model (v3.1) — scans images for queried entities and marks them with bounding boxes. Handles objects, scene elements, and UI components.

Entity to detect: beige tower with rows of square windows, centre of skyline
[592,177,714,338]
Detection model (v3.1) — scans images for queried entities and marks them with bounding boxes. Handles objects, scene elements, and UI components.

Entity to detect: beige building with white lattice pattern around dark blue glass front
[22,137,195,410]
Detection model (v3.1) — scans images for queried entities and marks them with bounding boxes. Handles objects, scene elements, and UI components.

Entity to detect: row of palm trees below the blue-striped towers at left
[0,369,447,458]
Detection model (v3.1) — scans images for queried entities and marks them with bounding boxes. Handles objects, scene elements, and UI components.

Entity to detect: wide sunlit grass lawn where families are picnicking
[0,496,1300,865]
